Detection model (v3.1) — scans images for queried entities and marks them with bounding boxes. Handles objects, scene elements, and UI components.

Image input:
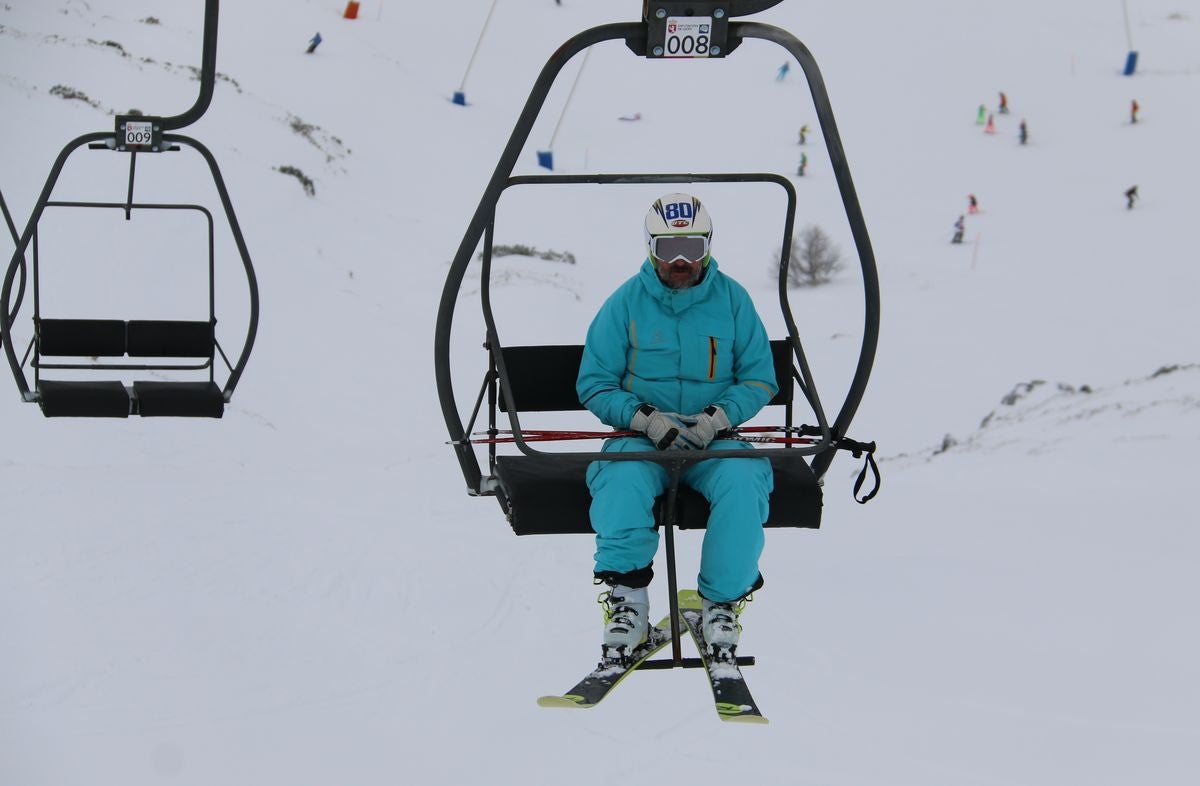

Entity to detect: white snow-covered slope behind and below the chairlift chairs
[0,0,1200,786]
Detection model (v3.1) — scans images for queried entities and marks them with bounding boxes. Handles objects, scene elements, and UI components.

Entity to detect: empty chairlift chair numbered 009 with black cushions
[0,0,258,418]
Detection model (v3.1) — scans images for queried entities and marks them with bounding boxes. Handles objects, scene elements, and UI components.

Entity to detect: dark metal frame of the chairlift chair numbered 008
[434,0,880,668]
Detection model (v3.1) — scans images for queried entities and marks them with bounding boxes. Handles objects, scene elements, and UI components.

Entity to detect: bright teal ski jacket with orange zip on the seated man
[576,259,776,428]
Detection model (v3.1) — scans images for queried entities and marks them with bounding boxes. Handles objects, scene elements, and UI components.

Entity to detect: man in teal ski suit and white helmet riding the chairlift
[576,193,775,659]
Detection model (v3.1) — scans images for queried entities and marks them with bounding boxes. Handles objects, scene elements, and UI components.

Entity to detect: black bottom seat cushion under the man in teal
[496,454,822,535]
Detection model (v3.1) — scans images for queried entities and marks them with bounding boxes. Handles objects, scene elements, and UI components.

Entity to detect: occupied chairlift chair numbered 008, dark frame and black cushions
[434,0,880,668]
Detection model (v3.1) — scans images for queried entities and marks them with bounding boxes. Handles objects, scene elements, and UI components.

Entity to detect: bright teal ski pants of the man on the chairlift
[587,437,774,601]
